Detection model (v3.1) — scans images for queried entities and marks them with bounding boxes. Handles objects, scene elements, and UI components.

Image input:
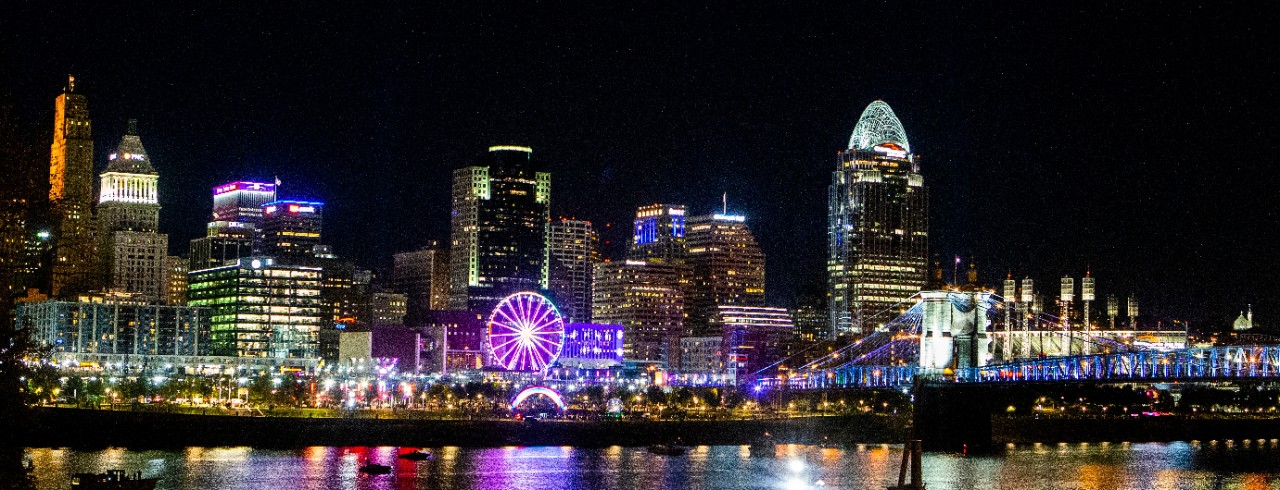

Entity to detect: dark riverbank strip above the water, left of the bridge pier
[23,408,910,448]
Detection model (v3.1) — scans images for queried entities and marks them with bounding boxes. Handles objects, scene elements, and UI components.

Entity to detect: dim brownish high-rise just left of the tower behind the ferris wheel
[392,241,449,325]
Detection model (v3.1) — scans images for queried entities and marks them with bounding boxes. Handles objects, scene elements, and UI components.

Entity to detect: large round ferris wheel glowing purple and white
[489,292,564,371]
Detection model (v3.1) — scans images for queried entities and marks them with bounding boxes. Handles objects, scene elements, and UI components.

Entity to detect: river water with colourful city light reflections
[27,439,1280,490]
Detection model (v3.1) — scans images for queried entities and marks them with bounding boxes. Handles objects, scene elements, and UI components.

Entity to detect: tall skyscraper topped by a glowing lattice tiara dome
[827,101,929,336]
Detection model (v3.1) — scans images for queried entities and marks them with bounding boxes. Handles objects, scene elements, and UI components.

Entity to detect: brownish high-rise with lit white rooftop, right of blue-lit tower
[685,214,764,336]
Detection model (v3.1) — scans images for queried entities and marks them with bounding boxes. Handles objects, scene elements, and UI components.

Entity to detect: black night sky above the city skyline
[0,1,1280,328]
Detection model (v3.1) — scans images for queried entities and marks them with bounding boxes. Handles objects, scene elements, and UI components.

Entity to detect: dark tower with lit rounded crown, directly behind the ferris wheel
[449,146,552,311]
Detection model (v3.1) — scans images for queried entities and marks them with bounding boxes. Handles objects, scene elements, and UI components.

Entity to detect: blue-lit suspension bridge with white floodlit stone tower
[756,290,1280,390]
